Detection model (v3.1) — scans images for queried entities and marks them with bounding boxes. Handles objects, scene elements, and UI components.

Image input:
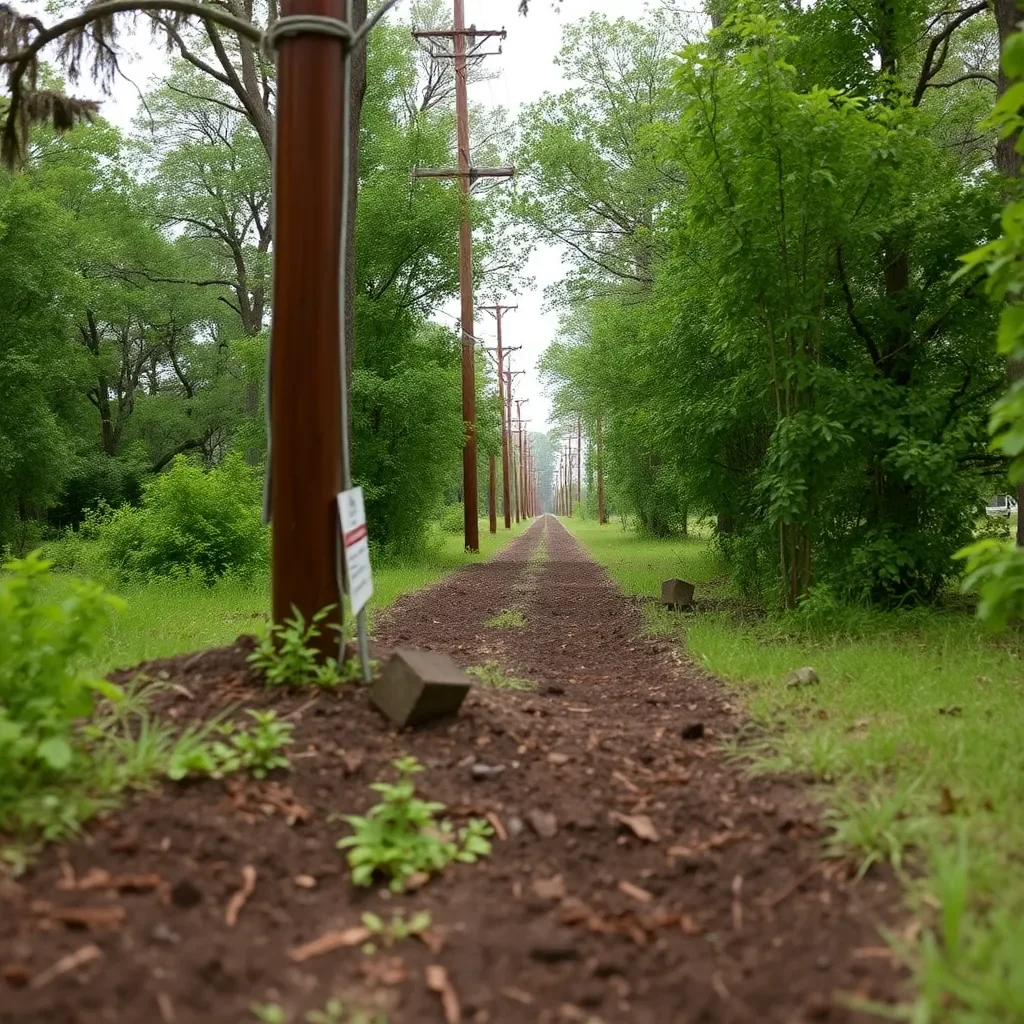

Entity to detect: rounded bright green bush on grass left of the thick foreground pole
[92,456,267,584]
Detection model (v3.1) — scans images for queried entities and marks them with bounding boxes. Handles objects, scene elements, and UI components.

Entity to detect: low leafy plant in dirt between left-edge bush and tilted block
[167,711,295,781]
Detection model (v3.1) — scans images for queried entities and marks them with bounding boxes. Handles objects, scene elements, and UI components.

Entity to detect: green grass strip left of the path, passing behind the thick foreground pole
[37,520,528,675]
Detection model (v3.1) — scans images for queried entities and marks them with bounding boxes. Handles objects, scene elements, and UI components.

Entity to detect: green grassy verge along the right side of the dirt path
[567,521,1024,1024]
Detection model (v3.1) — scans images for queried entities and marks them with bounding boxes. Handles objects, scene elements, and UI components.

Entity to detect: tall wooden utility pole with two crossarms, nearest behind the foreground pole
[413,6,515,552]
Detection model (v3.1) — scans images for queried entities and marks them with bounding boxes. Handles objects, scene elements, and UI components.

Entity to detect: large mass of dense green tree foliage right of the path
[532,0,1004,607]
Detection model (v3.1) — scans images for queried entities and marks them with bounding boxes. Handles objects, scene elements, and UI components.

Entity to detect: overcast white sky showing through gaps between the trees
[70,0,647,430]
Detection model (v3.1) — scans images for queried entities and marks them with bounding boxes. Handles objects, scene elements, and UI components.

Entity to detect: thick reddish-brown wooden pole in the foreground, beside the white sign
[269,0,351,655]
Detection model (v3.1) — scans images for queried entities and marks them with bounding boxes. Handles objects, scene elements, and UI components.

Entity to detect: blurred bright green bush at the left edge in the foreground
[0,552,120,830]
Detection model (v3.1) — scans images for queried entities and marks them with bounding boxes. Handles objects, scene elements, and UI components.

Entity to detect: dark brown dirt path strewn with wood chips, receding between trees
[0,517,900,1024]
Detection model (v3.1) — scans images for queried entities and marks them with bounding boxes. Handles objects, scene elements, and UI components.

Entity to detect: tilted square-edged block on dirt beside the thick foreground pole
[370,648,473,726]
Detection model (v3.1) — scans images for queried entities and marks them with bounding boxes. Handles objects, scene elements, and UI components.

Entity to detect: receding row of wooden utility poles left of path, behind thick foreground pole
[413,0,537,552]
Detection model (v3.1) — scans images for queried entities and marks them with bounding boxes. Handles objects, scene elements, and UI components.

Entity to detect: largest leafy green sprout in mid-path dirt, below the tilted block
[338,757,493,892]
